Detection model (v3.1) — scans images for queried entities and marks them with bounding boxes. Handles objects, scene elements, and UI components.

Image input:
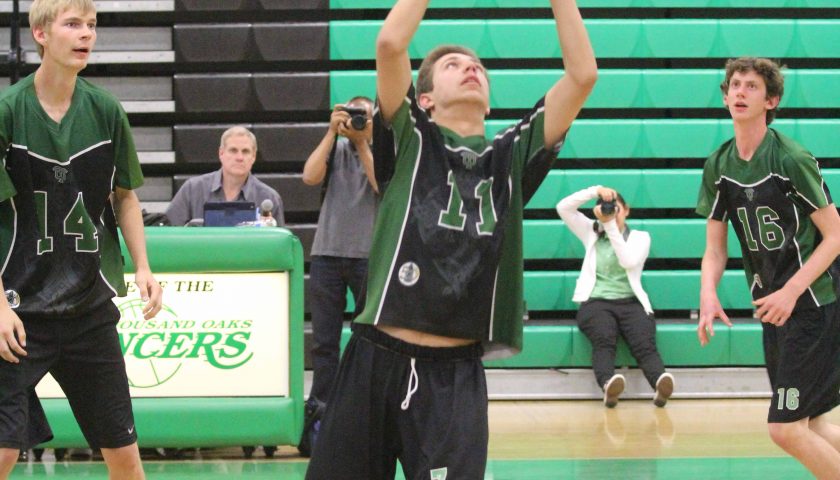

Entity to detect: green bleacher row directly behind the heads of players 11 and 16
[330,69,840,109]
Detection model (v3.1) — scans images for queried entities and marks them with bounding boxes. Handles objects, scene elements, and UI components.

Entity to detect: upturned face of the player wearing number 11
[421,53,490,111]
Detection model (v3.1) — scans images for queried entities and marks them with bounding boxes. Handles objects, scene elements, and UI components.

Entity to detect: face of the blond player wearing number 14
[32,8,96,72]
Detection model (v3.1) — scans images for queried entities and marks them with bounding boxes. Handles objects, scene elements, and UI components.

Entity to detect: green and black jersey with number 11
[356,87,562,353]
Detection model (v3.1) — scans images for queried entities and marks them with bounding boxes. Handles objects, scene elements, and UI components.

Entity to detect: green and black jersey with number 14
[0,74,143,316]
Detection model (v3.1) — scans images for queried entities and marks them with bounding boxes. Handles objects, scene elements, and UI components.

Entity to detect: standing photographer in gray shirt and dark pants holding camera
[298,97,378,456]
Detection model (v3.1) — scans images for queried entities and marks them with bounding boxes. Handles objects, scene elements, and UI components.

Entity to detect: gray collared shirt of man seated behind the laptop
[166,168,286,227]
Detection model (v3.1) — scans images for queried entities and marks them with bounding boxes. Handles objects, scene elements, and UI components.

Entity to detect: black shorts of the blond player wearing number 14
[0,301,137,449]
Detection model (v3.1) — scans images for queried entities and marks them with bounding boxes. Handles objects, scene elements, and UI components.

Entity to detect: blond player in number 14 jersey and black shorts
[0,0,162,480]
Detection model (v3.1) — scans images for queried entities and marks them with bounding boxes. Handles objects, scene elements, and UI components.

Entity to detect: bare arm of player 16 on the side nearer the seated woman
[697,219,732,346]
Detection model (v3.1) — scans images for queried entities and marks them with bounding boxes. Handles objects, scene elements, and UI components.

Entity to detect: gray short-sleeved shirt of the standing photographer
[312,137,379,258]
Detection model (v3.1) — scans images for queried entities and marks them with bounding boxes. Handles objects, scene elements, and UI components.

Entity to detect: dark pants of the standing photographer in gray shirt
[309,255,367,402]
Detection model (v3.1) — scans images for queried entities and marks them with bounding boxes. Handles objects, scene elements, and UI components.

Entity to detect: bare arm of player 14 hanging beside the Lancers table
[114,187,163,320]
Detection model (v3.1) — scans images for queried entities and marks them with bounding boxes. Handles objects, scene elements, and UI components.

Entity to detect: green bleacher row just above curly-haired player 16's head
[330,19,840,60]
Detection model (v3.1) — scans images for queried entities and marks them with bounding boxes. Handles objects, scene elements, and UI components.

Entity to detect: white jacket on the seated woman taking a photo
[557,185,653,314]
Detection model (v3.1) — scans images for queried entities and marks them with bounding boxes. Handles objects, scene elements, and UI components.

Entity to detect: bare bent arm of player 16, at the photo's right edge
[753,204,840,326]
